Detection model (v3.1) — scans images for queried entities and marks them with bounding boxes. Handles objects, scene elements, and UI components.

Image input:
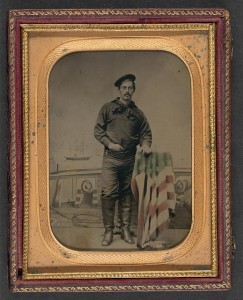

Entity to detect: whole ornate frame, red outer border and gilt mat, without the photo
[9,9,231,291]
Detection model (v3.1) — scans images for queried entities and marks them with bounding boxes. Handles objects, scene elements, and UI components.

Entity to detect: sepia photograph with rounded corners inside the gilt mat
[49,51,192,251]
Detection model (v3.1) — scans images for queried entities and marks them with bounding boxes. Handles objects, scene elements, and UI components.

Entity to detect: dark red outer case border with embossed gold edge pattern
[9,9,231,291]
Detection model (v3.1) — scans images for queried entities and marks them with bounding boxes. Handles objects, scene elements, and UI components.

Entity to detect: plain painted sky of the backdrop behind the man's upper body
[49,51,191,168]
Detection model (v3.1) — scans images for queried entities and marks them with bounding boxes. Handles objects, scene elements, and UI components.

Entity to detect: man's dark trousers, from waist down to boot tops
[101,153,134,231]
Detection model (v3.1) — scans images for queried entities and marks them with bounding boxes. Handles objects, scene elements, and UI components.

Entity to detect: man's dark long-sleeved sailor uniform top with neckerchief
[94,98,152,156]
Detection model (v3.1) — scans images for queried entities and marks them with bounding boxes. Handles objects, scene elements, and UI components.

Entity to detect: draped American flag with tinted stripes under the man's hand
[131,152,176,248]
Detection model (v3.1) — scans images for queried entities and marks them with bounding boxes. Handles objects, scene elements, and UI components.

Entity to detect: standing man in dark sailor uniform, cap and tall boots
[94,74,152,246]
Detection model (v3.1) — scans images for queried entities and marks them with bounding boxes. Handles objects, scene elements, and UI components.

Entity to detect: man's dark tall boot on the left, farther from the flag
[102,199,115,246]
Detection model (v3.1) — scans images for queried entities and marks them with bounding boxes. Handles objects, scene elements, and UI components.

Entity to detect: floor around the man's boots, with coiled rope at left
[51,202,191,251]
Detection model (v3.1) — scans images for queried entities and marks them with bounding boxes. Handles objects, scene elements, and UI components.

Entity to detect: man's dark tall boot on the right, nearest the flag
[120,195,134,244]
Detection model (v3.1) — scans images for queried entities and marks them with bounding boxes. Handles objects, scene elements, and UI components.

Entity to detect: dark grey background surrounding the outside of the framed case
[0,0,243,300]
